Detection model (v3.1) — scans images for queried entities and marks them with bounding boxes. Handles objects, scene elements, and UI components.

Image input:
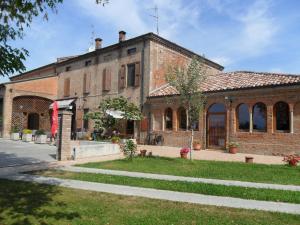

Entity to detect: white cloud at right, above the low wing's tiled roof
[207,0,280,68]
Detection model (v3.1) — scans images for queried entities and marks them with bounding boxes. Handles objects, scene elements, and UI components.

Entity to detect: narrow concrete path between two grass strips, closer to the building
[59,166,300,191]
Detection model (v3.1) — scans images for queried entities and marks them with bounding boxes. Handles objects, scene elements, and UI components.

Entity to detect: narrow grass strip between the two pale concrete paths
[39,170,300,204]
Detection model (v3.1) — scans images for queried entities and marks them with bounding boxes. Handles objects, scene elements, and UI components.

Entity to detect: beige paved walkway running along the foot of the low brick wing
[138,145,285,165]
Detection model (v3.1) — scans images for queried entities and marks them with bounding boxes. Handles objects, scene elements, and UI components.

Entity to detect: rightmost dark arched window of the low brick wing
[274,102,290,131]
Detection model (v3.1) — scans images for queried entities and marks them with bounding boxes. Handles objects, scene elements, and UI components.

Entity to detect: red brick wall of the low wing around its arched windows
[143,86,300,155]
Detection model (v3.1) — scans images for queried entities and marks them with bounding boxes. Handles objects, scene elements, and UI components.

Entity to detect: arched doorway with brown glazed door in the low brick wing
[207,103,226,148]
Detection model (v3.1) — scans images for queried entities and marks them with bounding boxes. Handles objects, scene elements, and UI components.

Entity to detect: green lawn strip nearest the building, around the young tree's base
[78,157,300,185]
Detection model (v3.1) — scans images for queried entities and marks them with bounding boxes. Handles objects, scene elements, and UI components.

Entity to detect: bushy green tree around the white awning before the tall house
[85,96,142,130]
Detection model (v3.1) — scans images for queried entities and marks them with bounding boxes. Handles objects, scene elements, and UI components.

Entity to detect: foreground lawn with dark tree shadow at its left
[0,180,300,225]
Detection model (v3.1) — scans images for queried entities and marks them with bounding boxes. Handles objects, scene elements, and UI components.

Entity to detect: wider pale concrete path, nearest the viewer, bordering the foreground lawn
[2,175,300,214]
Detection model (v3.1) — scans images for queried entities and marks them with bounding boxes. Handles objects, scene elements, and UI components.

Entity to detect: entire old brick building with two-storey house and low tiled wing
[0,31,300,154]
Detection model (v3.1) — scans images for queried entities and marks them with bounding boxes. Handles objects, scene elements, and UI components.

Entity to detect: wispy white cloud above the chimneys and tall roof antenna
[76,0,199,38]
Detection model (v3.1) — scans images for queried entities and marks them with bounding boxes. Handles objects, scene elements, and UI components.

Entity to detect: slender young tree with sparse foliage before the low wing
[165,56,207,159]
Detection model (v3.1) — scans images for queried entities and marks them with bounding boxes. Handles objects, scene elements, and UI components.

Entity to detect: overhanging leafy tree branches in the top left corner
[0,0,108,76]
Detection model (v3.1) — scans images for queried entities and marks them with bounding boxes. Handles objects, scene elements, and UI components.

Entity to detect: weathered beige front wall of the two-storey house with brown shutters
[57,41,149,134]
